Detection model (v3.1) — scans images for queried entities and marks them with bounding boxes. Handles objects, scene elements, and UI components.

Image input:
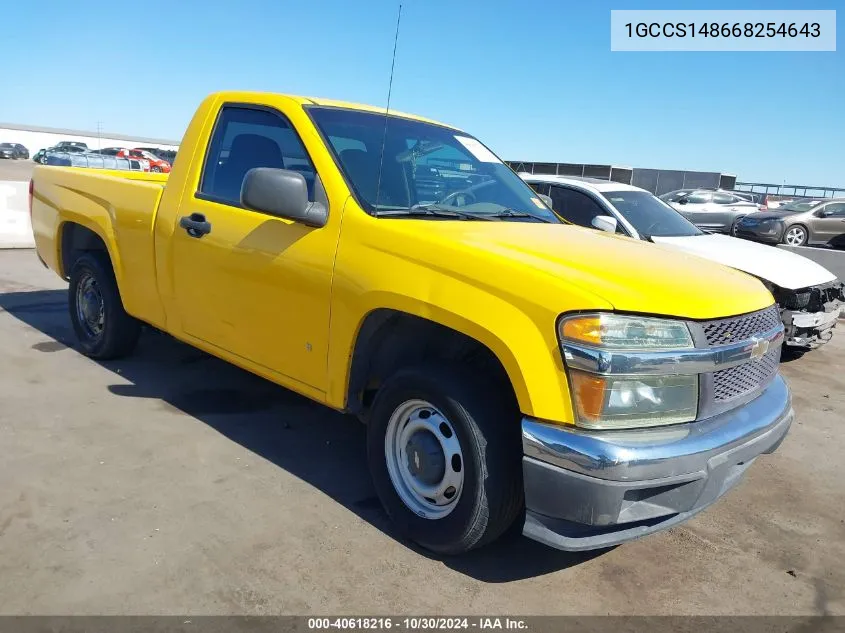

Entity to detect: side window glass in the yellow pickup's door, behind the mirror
[197,106,316,206]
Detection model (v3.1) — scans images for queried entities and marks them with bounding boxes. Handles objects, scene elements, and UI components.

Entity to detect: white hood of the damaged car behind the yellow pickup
[652,235,836,290]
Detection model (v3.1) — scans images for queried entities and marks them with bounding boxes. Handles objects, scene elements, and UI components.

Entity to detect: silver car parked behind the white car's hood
[660,189,759,235]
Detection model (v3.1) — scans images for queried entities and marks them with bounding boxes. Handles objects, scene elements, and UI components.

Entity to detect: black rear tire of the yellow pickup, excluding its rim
[68,251,141,360]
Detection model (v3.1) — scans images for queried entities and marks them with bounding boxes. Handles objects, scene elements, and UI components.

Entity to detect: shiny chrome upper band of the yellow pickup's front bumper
[522,375,793,481]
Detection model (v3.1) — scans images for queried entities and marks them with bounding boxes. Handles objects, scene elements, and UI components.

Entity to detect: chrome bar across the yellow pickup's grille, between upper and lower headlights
[562,324,784,375]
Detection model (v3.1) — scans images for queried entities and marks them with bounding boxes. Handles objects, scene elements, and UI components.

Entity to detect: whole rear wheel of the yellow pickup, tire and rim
[68,252,141,360]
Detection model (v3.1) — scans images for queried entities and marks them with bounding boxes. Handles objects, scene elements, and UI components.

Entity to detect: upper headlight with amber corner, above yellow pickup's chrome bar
[559,313,693,350]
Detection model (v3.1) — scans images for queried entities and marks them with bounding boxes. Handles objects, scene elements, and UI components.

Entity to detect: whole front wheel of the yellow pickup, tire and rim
[367,365,524,554]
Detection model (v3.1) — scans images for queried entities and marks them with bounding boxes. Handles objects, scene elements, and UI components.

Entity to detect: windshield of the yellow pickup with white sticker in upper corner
[308,107,559,223]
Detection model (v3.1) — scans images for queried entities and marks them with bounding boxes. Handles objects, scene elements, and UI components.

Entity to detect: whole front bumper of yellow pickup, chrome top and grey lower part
[522,376,794,551]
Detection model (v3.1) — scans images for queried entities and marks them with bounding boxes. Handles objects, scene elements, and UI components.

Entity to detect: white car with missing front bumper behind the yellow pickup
[520,173,845,349]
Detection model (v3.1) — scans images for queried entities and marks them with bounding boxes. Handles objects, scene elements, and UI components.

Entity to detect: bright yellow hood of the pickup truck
[382,220,774,319]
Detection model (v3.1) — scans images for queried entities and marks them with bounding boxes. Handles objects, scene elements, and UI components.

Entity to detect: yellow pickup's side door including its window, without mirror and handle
[171,105,340,392]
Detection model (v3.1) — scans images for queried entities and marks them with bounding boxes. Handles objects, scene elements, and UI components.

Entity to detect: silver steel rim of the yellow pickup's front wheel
[384,400,464,519]
